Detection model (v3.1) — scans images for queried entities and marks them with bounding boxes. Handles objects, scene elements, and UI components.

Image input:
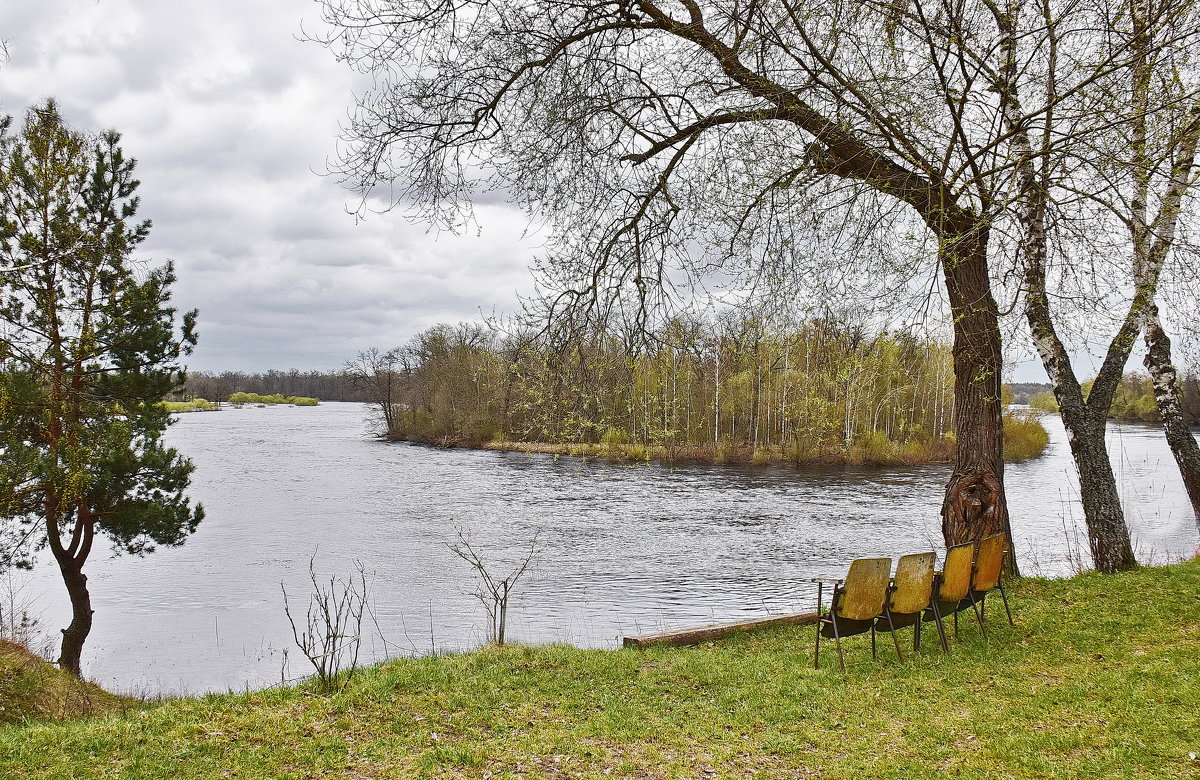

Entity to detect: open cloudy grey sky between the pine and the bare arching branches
[0,0,538,371]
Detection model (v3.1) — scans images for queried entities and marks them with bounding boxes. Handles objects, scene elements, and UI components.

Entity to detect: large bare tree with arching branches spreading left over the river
[314,0,1046,552]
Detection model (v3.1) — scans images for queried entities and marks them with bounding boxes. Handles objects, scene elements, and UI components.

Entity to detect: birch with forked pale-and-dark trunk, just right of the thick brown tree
[985,0,1200,571]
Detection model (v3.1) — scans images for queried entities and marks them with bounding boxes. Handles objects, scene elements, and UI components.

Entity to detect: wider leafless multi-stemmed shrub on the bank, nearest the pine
[280,556,367,692]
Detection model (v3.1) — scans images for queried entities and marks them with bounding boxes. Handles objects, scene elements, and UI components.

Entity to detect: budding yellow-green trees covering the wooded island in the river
[350,316,1040,462]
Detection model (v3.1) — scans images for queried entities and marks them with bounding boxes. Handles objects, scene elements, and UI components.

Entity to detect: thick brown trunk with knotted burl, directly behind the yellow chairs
[941,218,1016,574]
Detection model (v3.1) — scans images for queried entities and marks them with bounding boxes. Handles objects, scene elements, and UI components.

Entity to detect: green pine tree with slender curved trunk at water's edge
[0,102,203,674]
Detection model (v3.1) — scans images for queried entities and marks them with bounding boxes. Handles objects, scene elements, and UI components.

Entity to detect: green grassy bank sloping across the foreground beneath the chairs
[0,562,1200,780]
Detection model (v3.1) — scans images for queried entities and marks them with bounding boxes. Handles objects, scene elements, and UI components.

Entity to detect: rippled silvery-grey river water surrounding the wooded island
[16,403,1198,694]
